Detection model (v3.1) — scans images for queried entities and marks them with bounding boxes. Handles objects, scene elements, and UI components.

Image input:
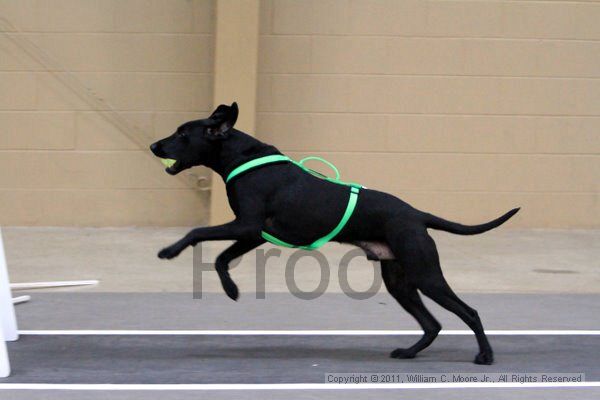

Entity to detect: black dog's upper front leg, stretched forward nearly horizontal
[158,220,260,259]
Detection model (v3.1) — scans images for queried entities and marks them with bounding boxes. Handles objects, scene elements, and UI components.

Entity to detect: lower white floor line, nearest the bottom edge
[0,382,600,391]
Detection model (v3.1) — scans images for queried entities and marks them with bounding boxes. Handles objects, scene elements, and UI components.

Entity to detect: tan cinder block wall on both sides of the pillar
[0,0,600,227]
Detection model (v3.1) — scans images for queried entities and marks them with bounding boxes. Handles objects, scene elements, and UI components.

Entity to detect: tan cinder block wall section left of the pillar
[0,0,214,226]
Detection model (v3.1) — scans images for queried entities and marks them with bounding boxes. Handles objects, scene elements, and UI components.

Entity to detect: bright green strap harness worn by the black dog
[225,154,362,250]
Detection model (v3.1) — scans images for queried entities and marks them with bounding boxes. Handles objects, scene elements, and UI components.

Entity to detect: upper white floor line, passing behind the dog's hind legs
[19,329,600,336]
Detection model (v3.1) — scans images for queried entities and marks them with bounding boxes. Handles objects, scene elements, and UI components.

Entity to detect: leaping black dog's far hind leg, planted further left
[381,260,442,358]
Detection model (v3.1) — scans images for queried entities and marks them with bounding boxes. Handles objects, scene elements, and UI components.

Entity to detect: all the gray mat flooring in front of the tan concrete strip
[0,292,600,400]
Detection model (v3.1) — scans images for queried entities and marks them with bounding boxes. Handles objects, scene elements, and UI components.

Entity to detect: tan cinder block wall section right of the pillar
[255,0,600,227]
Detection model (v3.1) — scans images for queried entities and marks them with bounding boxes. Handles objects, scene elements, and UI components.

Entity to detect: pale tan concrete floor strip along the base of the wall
[2,228,600,293]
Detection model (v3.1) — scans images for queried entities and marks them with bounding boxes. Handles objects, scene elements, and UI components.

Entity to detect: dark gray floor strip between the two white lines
[0,335,600,384]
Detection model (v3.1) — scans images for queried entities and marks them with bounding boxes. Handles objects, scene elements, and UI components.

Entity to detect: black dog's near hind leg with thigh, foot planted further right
[389,227,494,365]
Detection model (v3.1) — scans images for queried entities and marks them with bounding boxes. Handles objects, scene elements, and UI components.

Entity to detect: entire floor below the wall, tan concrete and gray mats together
[0,228,600,400]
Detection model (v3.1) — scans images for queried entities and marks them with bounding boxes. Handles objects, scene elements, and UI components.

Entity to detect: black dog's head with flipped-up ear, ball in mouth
[150,103,238,175]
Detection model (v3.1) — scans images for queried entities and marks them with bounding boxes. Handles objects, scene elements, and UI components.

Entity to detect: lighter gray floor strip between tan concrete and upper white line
[10,292,600,330]
